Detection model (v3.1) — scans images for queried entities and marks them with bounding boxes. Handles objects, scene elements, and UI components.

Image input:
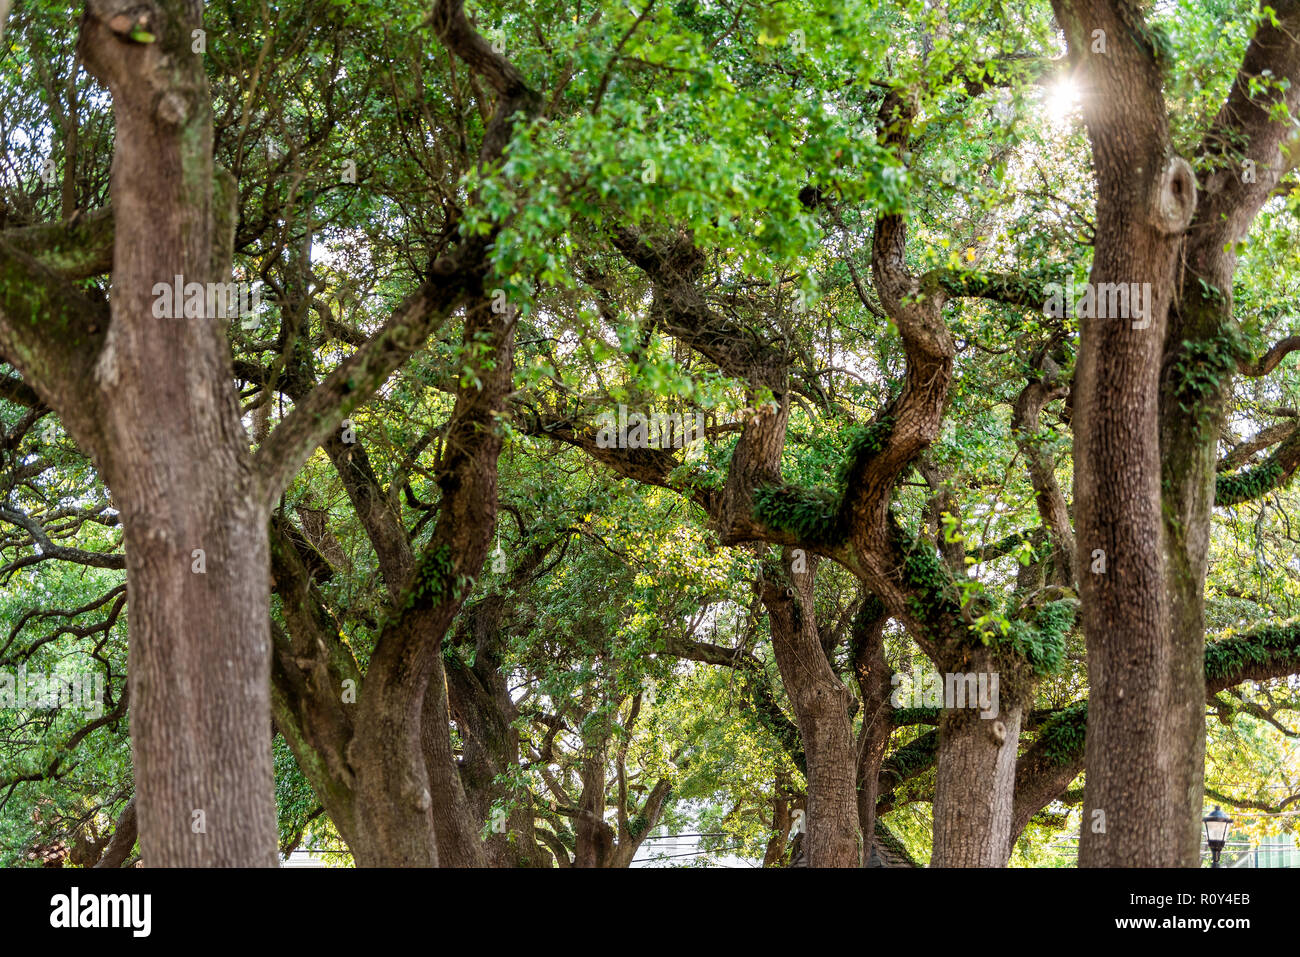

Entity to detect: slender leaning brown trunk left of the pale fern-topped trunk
[762,549,861,867]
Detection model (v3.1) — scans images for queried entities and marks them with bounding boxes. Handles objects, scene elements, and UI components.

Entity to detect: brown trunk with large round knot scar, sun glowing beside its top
[1053,0,1200,866]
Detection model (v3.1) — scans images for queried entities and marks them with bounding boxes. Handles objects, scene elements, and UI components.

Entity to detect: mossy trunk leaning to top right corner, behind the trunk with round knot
[1160,0,1300,865]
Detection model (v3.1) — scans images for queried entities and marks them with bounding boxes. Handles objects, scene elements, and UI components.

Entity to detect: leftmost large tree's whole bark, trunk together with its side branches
[0,0,538,866]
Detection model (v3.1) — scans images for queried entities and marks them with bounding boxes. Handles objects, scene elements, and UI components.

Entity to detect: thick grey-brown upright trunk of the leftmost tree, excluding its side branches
[81,0,276,866]
